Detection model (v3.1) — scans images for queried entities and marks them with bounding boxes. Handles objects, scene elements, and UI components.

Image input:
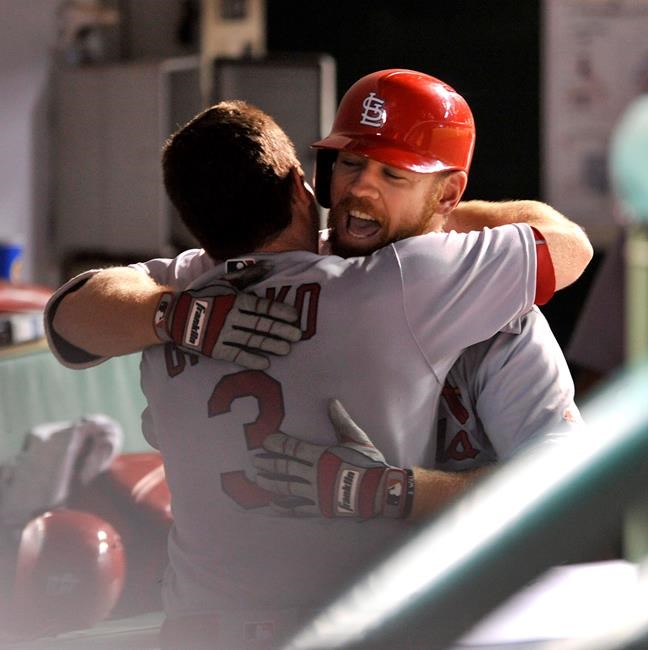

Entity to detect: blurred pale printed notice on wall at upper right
[542,0,648,246]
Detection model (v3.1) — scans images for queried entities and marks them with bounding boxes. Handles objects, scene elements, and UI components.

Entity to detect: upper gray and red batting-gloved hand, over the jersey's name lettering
[154,265,302,370]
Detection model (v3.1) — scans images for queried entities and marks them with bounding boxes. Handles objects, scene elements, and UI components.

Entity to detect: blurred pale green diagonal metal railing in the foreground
[282,363,648,650]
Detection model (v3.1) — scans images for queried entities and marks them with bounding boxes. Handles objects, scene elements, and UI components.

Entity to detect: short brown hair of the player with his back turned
[162,101,301,260]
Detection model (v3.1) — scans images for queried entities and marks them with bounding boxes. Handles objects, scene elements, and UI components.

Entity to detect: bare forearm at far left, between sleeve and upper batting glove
[52,268,165,357]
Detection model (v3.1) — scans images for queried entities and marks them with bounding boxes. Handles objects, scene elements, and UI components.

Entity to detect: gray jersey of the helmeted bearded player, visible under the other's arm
[434,307,583,471]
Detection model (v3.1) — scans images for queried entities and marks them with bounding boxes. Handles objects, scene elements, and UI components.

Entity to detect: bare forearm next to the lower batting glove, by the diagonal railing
[409,465,493,520]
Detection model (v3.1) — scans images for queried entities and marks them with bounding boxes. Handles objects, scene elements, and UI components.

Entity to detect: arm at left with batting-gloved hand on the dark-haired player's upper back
[46,264,302,369]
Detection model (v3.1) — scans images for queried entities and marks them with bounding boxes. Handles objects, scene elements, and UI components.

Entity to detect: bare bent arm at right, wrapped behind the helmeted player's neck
[444,201,594,289]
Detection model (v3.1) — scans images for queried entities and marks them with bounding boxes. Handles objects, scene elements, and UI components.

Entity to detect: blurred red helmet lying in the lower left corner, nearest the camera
[12,509,125,637]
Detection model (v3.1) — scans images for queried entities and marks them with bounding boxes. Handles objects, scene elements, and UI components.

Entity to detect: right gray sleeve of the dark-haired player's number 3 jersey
[394,224,536,374]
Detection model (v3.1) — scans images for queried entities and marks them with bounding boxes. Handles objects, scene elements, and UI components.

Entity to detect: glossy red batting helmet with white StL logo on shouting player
[312,69,475,207]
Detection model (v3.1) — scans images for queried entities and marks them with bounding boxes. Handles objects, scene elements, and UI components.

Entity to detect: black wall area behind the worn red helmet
[267,0,540,199]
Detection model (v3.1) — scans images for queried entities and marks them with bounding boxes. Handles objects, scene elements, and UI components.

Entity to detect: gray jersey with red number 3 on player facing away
[43,224,537,628]
